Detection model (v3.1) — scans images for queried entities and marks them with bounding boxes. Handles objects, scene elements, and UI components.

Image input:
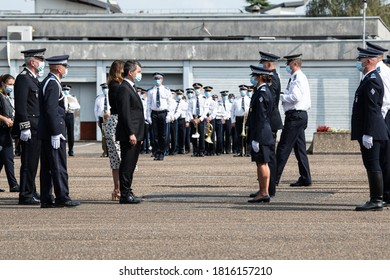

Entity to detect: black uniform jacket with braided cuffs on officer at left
[12,68,39,137]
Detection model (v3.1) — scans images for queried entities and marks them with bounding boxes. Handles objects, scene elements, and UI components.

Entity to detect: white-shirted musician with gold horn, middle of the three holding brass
[203,86,217,156]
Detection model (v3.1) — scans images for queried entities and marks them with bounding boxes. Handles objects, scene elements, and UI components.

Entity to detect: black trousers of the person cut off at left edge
[0,127,18,188]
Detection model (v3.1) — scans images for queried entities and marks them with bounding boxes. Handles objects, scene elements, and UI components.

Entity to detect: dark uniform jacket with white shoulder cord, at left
[38,73,66,140]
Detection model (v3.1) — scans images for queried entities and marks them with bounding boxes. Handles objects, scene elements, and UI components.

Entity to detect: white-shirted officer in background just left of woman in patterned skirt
[94,83,111,157]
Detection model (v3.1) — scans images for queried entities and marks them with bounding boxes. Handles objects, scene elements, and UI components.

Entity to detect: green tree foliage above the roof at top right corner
[306,0,390,26]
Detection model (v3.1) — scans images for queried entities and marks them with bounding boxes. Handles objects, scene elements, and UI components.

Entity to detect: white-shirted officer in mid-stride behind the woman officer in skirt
[276,54,311,187]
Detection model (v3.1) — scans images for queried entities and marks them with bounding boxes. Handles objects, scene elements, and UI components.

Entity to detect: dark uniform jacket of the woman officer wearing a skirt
[248,84,274,146]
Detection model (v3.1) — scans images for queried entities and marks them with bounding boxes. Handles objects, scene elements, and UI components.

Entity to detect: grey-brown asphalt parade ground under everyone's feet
[0,142,390,260]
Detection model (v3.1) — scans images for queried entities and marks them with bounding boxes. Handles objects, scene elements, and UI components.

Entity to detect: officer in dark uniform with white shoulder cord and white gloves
[38,55,80,208]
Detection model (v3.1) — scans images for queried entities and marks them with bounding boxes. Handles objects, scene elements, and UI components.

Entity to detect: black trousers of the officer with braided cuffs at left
[19,122,41,200]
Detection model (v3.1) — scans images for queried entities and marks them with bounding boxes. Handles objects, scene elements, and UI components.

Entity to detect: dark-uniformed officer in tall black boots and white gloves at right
[351,48,390,211]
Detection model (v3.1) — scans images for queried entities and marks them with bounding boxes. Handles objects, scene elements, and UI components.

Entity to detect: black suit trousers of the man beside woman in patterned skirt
[119,141,141,198]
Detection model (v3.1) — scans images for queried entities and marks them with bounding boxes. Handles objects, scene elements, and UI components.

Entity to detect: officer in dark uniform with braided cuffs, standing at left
[12,49,46,205]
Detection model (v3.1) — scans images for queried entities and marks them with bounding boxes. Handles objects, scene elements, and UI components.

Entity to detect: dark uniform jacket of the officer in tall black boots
[351,70,389,141]
